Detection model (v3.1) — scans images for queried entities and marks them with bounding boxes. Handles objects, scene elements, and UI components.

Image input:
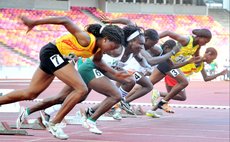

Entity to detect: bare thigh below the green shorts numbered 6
[88,76,120,96]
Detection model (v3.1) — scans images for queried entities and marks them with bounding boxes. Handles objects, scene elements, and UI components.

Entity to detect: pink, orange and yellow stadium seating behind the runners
[0,7,229,65]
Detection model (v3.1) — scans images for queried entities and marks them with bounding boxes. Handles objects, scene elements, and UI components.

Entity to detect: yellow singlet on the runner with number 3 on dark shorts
[171,36,200,63]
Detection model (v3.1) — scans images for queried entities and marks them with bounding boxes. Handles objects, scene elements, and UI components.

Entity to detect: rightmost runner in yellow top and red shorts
[146,47,227,117]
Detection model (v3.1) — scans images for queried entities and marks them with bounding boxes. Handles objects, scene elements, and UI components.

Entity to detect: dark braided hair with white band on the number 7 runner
[86,24,124,44]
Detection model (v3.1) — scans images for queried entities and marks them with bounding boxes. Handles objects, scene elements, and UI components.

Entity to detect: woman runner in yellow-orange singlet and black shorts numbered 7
[0,16,129,139]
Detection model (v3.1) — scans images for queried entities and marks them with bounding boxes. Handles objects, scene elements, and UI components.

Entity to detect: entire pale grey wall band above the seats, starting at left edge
[0,0,208,15]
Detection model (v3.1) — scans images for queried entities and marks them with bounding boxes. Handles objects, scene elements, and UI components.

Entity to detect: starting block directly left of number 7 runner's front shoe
[10,117,46,130]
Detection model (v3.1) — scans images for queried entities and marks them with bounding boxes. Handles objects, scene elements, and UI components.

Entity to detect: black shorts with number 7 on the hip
[39,43,69,74]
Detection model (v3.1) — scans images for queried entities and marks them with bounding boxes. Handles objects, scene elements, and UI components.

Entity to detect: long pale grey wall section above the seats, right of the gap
[101,0,208,15]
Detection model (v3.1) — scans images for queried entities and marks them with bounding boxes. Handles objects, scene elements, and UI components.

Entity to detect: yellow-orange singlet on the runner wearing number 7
[55,33,99,58]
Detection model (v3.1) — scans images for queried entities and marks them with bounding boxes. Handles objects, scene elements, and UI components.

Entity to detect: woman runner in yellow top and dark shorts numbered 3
[146,29,212,113]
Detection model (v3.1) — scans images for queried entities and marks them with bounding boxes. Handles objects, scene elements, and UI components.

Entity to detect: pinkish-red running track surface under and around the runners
[0,81,230,142]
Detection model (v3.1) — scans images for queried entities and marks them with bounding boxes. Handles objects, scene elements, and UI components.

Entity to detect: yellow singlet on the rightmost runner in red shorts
[180,62,204,76]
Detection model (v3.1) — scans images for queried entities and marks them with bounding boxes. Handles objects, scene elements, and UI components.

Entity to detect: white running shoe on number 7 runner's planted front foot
[48,123,69,140]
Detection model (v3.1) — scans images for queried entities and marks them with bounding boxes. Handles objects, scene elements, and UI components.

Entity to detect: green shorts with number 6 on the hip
[78,59,104,85]
